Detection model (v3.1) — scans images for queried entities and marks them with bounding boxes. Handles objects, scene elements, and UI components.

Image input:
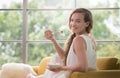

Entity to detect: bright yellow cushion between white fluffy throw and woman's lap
[37,57,51,75]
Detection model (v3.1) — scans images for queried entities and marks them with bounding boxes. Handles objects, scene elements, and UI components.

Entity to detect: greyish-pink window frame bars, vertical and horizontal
[0,0,120,63]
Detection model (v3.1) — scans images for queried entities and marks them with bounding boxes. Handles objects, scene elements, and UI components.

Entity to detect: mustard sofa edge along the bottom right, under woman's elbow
[70,70,120,78]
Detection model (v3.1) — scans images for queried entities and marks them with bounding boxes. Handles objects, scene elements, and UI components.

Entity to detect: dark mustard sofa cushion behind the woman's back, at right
[97,57,119,70]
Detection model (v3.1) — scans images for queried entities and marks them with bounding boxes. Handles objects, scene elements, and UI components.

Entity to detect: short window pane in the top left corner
[0,0,23,9]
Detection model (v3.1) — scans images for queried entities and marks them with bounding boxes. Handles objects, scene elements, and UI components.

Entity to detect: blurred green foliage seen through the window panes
[0,0,120,65]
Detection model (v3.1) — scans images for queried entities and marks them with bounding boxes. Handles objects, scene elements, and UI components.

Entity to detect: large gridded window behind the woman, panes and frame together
[0,0,120,65]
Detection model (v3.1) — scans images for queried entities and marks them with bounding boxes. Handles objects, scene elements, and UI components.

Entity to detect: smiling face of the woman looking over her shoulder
[69,13,89,35]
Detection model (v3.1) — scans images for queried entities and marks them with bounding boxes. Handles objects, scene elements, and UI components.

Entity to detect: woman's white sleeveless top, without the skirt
[66,35,96,70]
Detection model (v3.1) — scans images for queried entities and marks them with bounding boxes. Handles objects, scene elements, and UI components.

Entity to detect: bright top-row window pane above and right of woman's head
[76,0,120,8]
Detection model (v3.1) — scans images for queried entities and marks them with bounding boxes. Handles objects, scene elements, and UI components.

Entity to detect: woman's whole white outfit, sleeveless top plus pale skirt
[43,35,96,78]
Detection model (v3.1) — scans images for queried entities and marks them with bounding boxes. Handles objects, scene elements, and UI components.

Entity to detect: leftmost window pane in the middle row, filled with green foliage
[0,11,22,40]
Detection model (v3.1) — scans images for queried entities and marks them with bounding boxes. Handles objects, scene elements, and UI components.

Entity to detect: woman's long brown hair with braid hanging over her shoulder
[64,8,93,63]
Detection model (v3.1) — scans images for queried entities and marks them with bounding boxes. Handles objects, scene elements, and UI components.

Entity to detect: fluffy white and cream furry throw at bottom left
[0,63,37,78]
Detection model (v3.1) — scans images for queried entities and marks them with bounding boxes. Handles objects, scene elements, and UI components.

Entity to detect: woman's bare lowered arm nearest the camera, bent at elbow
[62,36,88,72]
